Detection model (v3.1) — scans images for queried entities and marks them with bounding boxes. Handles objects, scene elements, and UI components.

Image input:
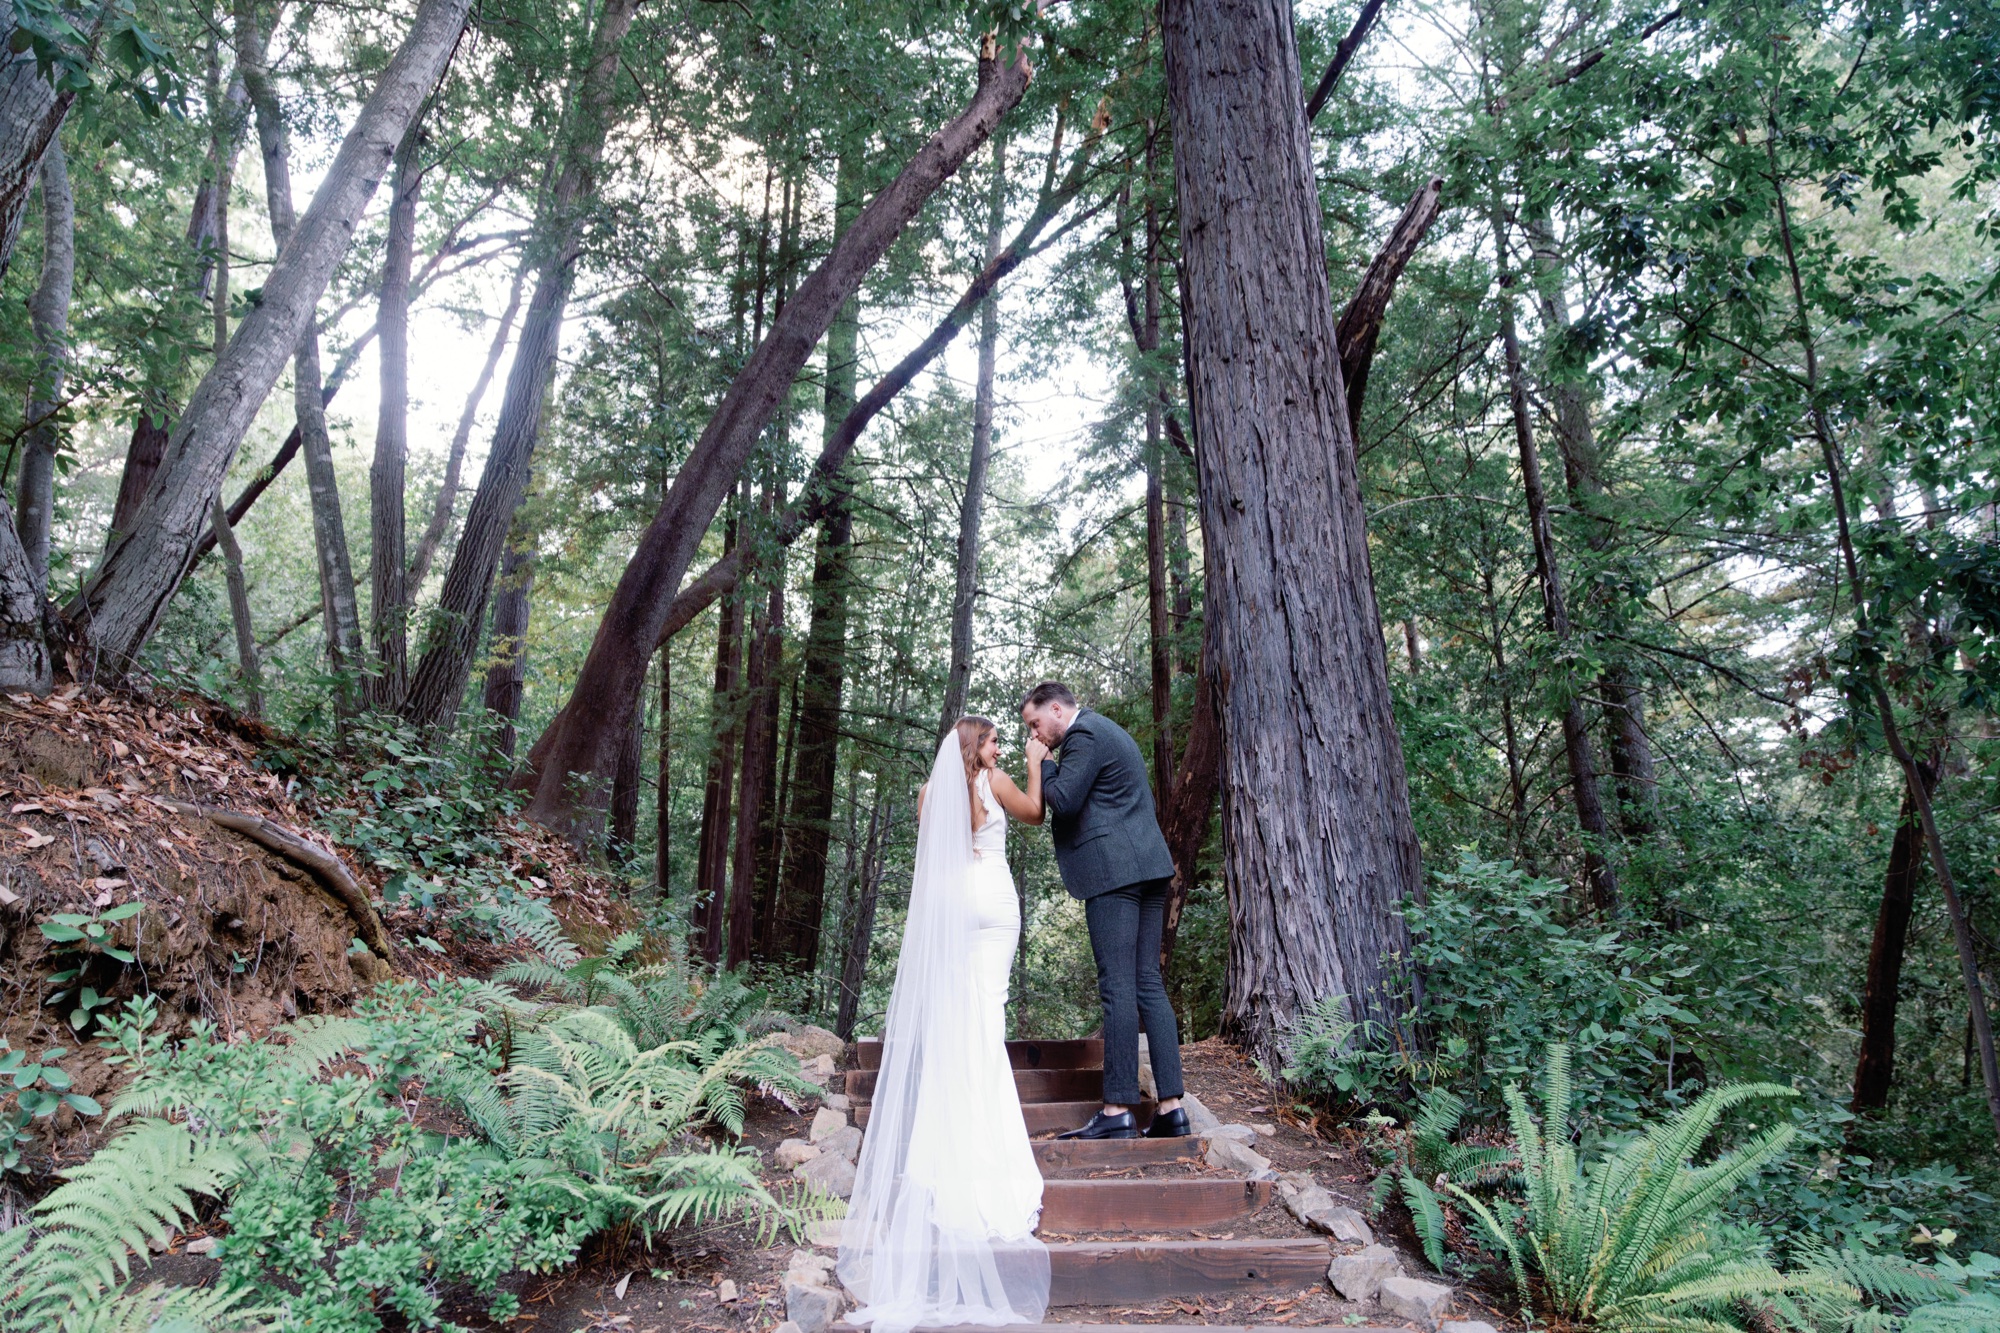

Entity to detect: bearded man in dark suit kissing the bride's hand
[1020,681,1188,1139]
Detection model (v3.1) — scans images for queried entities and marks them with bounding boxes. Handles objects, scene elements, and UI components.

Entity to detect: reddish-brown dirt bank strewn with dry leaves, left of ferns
[0,691,620,1165]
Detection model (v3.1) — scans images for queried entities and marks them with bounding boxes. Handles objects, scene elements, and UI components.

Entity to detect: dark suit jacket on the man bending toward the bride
[1042,709,1174,899]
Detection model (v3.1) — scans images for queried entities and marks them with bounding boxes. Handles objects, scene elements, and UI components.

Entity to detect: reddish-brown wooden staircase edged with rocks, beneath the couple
[834,1039,1332,1333]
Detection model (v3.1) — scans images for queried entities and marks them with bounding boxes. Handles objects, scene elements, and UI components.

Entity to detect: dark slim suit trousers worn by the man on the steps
[1084,879,1184,1107]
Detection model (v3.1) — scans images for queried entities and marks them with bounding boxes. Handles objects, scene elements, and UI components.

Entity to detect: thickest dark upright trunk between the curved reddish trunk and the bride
[770,128,864,969]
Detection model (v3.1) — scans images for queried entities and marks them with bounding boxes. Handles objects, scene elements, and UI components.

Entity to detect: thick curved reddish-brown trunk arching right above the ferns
[528,50,1028,843]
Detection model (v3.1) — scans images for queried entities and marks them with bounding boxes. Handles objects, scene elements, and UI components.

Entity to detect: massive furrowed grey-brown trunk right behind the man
[1162,0,1424,1065]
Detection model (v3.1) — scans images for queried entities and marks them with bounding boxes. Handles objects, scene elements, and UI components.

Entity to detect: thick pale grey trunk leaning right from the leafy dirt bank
[72,0,470,677]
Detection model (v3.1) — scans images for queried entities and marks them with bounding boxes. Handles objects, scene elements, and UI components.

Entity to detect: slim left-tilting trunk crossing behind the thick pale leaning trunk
[236,0,362,696]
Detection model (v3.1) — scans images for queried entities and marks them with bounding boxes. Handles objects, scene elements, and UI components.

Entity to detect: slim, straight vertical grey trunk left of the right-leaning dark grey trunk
[368,120,424,713]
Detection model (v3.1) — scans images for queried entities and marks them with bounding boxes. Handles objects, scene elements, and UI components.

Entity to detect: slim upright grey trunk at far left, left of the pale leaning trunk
[14,138,76,598]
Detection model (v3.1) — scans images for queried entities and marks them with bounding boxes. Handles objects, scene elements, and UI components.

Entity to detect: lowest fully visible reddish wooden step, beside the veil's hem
[1048,1241,1332,1305]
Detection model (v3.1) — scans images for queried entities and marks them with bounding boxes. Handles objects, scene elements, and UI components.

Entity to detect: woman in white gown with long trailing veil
[838,717,1048,1333]
